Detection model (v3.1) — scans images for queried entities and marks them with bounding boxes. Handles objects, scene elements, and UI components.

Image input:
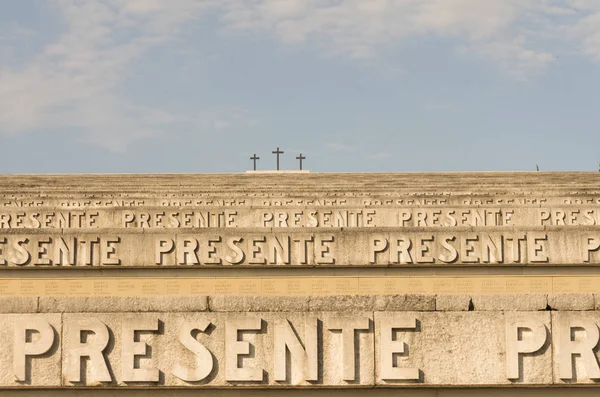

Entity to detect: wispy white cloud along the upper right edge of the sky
[223,0,600,80]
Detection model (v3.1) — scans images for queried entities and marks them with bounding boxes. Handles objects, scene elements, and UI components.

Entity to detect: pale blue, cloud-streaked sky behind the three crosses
[0,0,600,173]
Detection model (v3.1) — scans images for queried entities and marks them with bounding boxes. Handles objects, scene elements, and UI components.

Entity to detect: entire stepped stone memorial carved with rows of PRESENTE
[0,171,600,397]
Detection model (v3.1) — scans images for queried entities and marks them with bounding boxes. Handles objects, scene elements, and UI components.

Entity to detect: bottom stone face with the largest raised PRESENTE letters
[0,312,600,387]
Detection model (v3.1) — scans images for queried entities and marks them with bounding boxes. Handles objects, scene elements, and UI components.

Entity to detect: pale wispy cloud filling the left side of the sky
[0,0,246,151]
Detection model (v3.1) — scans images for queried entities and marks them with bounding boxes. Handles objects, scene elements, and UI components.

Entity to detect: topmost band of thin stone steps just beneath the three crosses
[0,172,600,193]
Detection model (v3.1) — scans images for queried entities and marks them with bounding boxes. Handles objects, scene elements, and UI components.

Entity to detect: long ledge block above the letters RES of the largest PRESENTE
[38,296,208,313]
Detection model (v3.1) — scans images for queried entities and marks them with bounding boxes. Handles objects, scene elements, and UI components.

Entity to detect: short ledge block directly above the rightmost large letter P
[471,294,548,311]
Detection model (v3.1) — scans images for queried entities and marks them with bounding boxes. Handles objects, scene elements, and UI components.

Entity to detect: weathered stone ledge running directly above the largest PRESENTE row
[0,294,600,313]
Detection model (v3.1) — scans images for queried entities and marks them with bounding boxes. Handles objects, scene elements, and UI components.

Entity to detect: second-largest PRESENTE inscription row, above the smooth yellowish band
[0,228,600,267]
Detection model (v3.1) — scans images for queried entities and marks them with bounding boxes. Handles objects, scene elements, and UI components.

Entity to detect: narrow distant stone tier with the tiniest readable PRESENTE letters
[0,196,600,209]
